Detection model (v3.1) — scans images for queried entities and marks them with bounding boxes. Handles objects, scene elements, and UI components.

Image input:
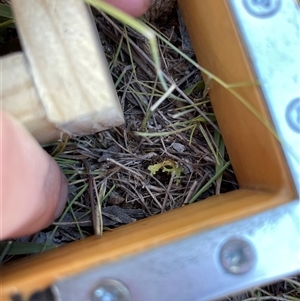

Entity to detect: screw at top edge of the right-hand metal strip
[243,0,281,18]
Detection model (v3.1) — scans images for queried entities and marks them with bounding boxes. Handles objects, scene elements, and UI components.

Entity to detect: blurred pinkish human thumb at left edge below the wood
[0,111,68,240]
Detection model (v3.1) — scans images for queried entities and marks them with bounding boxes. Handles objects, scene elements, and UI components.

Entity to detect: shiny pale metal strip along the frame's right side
[229,0,300,194]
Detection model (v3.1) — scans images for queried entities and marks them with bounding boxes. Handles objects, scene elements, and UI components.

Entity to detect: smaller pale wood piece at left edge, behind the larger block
[0,52,61,143]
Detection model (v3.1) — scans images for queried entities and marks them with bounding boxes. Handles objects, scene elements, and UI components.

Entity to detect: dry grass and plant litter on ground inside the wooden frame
[39,6,237,242]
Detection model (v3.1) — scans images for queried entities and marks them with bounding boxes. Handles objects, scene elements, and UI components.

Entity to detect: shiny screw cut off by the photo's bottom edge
[92,279,132,301]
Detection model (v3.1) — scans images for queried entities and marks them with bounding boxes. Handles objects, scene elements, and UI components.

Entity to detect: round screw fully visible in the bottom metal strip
[220,239,255,275]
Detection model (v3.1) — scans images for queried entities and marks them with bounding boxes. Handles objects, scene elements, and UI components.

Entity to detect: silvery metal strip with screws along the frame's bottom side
[54,200,300,301]
